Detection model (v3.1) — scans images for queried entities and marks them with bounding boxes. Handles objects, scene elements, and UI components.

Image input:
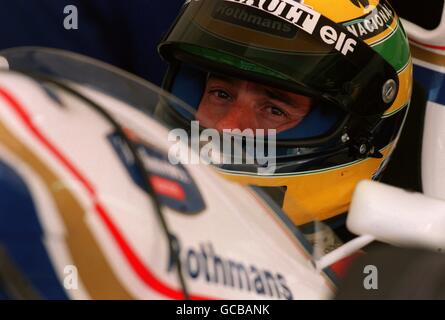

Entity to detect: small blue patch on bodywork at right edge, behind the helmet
[414,65,445,105]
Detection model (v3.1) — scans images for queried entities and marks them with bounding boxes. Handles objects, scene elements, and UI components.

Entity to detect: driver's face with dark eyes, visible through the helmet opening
[196,75,312,133]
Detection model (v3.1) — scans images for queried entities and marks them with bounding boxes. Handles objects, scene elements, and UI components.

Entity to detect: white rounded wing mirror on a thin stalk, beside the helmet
[347,181,445,250]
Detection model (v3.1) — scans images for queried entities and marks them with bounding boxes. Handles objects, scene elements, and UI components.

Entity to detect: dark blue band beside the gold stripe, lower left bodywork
[0,161,68,300]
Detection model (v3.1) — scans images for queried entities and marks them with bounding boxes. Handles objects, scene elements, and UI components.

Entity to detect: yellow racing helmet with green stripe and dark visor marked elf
[158,0,412,225]
